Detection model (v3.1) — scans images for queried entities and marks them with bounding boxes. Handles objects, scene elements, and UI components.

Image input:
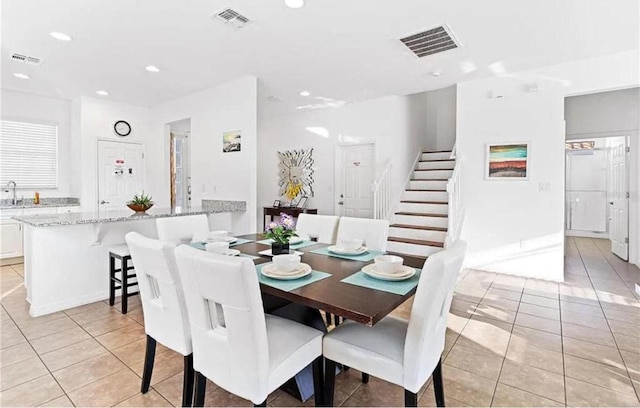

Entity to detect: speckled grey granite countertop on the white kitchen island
[13,202,246,227]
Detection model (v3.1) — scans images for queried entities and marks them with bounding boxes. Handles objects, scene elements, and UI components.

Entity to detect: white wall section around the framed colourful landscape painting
[457,77,564,281]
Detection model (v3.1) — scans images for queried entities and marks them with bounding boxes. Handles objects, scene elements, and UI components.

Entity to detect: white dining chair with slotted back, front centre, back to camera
[176,245,324,407]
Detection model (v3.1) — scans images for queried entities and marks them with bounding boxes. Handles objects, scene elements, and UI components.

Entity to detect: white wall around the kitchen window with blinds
[1,89,71,199]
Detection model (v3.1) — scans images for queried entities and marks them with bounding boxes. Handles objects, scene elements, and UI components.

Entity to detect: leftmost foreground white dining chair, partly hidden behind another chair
[125,232,194,407]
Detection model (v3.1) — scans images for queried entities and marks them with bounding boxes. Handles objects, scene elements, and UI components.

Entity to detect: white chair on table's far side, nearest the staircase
[337,217,389,252]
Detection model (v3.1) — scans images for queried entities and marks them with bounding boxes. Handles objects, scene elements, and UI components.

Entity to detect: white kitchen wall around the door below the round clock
[72,96,154,211]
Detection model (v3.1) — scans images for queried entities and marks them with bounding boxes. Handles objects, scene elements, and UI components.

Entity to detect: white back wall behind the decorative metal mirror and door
[258,94,426,230]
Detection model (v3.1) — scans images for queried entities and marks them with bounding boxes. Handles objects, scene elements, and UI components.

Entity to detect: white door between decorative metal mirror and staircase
[338,144,375,218]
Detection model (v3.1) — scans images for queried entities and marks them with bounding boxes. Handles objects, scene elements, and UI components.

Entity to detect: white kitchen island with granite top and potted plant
[13,201,246,317]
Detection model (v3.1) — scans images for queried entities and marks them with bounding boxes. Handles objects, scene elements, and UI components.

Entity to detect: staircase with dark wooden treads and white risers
[387,151,456,257]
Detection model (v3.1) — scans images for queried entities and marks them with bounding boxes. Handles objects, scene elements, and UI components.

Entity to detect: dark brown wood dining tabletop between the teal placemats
[233,234,424,326]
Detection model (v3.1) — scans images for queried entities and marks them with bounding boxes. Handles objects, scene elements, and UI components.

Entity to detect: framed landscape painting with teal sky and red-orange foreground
[485,142,530,180]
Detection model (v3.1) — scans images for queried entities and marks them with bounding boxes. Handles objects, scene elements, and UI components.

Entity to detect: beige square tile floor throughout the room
[0,238,640,406]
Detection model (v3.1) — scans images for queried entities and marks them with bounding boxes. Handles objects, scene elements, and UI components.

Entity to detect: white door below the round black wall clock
[98,140,144,210]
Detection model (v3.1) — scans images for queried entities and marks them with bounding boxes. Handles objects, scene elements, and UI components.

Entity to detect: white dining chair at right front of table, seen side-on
[323,241,467,407]
